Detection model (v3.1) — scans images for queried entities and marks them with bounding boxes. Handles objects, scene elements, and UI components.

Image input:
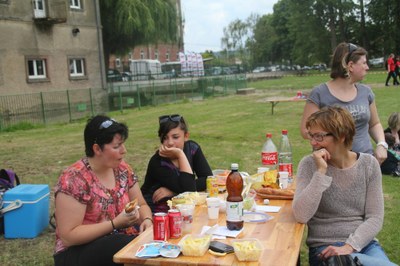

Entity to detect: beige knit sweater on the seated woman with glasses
[293,153,384,251]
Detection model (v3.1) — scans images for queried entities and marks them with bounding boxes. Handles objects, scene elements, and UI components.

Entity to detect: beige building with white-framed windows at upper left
[0,0,106,95]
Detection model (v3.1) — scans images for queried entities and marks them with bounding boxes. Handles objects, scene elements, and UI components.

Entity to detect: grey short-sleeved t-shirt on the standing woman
[308,83,375,154]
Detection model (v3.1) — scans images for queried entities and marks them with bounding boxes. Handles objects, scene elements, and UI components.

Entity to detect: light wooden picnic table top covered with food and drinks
[114,195,305,266]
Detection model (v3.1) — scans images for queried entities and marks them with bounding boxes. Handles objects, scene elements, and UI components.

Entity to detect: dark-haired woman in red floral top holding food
[54,116,153,266]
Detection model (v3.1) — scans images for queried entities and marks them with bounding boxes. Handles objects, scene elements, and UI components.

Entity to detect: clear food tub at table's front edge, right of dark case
[232,238,263,261]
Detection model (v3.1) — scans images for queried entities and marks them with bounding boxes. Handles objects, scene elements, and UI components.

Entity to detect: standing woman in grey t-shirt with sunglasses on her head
[300,43,388,164]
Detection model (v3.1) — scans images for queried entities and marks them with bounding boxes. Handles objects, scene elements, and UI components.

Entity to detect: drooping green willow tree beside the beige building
[99,0,178,69]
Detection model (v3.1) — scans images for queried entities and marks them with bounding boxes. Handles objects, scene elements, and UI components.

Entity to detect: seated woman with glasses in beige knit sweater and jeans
[292,106,395,266]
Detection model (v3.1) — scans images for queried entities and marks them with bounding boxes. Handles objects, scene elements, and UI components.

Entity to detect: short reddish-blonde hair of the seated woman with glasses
[306,106,356,148]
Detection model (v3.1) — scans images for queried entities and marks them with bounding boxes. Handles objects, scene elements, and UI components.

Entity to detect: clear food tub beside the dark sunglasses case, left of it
[178,235,211,257]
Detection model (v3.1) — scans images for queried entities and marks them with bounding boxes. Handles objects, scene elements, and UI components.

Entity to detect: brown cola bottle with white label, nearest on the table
[226,163,243,230]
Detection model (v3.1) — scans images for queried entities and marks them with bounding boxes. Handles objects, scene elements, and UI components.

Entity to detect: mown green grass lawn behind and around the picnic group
[0,73,400,265]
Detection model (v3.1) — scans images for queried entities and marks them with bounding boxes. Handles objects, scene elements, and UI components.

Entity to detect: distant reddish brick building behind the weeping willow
[109,0,184,72]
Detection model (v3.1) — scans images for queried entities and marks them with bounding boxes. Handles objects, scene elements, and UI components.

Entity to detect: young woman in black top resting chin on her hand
[141,114,212,212]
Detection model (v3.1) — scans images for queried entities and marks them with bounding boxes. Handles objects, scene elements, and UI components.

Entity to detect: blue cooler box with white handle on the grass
[2,184,50,238]
